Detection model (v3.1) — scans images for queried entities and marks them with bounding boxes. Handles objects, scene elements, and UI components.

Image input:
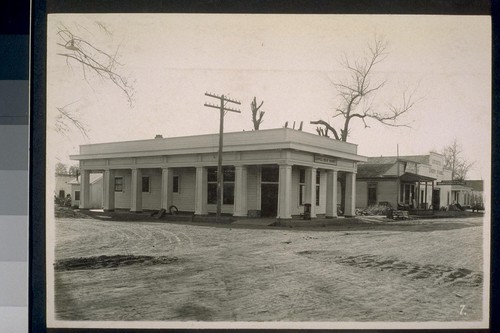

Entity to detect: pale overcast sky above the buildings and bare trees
[47,14,491,179]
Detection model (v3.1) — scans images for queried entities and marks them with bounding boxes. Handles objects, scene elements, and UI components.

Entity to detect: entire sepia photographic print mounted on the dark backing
[46,14,492,329]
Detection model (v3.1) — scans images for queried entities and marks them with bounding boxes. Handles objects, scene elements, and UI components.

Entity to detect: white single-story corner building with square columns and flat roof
[71,128,366,219]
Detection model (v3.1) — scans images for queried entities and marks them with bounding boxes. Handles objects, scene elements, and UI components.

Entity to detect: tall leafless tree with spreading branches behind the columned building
[310,38,417,210]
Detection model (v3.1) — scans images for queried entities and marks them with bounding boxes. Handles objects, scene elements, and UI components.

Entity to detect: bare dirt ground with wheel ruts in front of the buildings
[51,218,483,321]
